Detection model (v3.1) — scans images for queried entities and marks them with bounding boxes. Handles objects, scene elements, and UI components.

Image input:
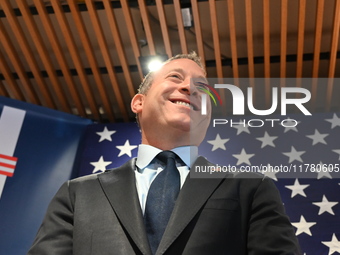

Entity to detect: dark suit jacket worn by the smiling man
[28,157,300,255]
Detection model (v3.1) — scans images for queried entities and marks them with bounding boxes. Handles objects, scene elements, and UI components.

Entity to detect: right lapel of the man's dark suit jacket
[156,157,223,254]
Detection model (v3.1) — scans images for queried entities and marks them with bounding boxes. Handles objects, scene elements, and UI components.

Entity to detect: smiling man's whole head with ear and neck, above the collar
[131,57,210,150]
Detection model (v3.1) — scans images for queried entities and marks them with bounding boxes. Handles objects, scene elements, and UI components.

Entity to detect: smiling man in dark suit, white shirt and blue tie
[28,53,300,255]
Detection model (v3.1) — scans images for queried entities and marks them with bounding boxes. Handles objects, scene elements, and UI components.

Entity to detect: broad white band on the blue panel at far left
[0,106,26,198]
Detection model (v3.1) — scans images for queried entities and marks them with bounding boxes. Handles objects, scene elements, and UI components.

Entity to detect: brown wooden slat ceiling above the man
[0,0,340,122]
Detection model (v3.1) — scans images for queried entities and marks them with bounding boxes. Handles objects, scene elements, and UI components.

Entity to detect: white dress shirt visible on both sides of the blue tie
[135,144,198,214]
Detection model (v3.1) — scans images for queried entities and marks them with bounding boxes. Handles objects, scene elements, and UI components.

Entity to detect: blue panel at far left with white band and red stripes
[0,96,93,255]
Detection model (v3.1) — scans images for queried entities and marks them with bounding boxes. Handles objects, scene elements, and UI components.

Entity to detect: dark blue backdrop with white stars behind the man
[79,113,340,255]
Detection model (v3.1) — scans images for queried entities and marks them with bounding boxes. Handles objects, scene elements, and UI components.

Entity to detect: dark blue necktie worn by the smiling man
[144,151,180,254]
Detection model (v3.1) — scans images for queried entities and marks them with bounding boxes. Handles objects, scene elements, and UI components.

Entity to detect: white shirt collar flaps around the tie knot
[136,144,198,169]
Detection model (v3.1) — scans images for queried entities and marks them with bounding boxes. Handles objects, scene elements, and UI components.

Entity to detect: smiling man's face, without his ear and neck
[131,59,211,145]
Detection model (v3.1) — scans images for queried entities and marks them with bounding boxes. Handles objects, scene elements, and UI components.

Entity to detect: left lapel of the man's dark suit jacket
[99,159,151,254]
